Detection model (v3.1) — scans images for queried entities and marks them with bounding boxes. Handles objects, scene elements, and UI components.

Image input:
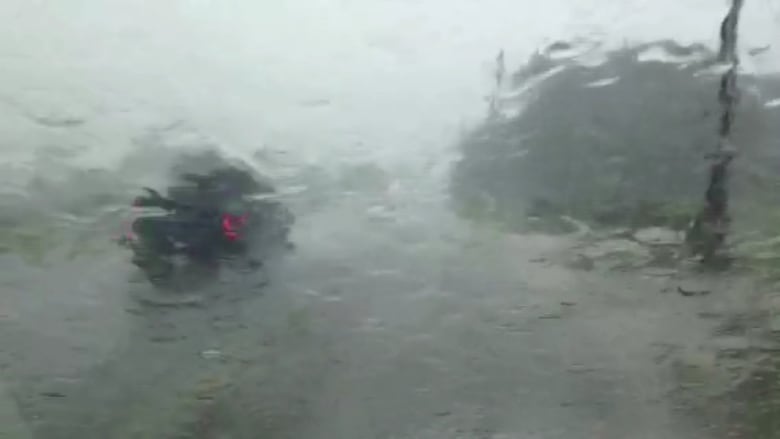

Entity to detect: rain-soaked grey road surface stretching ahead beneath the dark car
[2,193,744,439]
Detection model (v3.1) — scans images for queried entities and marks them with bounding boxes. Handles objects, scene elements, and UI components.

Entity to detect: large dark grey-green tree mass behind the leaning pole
[451,41,780,232]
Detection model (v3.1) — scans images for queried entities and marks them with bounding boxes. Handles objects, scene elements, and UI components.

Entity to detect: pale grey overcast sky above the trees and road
[0,0,780,171]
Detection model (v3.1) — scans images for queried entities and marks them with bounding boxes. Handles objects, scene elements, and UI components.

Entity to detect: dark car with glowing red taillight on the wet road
[123,166,293,285]
